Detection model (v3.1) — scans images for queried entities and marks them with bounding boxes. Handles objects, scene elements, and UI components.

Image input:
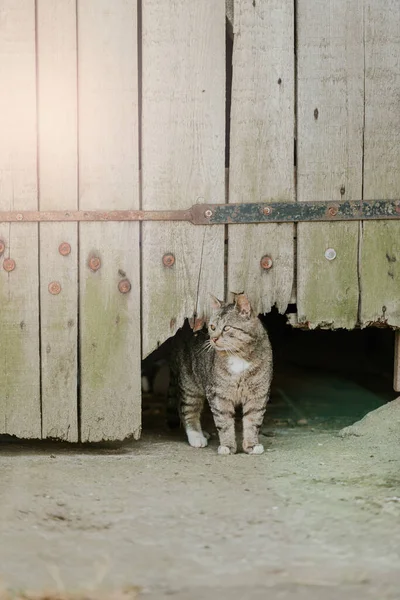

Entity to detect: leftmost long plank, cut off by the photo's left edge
[0,0,41,438]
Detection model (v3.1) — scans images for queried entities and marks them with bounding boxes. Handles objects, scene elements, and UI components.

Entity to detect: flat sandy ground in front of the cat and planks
[0,394,400,600]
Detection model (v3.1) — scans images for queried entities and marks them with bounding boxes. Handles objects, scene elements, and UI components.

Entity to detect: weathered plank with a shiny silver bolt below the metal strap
[297,0,364,328]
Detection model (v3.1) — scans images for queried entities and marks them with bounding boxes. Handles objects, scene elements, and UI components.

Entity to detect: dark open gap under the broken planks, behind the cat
[142,310,396,441]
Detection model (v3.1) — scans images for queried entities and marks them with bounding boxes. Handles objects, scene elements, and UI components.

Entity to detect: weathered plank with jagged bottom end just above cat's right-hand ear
[228,0,295,313]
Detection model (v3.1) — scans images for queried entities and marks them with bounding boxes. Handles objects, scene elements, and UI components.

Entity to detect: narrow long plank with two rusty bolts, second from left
[37,0,78,442]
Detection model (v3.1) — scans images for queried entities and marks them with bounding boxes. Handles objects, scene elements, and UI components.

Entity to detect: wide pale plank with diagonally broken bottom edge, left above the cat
[142,0,225,356]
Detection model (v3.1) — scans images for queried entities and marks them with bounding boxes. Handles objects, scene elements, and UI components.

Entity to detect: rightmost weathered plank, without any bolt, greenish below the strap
[360,0,400,327]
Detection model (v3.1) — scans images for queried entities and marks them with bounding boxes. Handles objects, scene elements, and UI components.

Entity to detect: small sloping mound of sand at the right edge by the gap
[339,397,400,444]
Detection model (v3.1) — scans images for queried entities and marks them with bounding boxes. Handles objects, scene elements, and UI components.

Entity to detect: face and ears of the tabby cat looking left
[208,294,256,354]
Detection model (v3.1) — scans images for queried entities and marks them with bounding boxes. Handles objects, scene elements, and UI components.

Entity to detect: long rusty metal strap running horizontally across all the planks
[0,200,400,225]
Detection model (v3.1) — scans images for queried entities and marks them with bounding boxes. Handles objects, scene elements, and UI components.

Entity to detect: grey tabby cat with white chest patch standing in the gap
[170,294,272,454]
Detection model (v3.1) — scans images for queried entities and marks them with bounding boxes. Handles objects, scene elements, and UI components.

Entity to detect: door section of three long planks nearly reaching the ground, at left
[0,0,141,442]
